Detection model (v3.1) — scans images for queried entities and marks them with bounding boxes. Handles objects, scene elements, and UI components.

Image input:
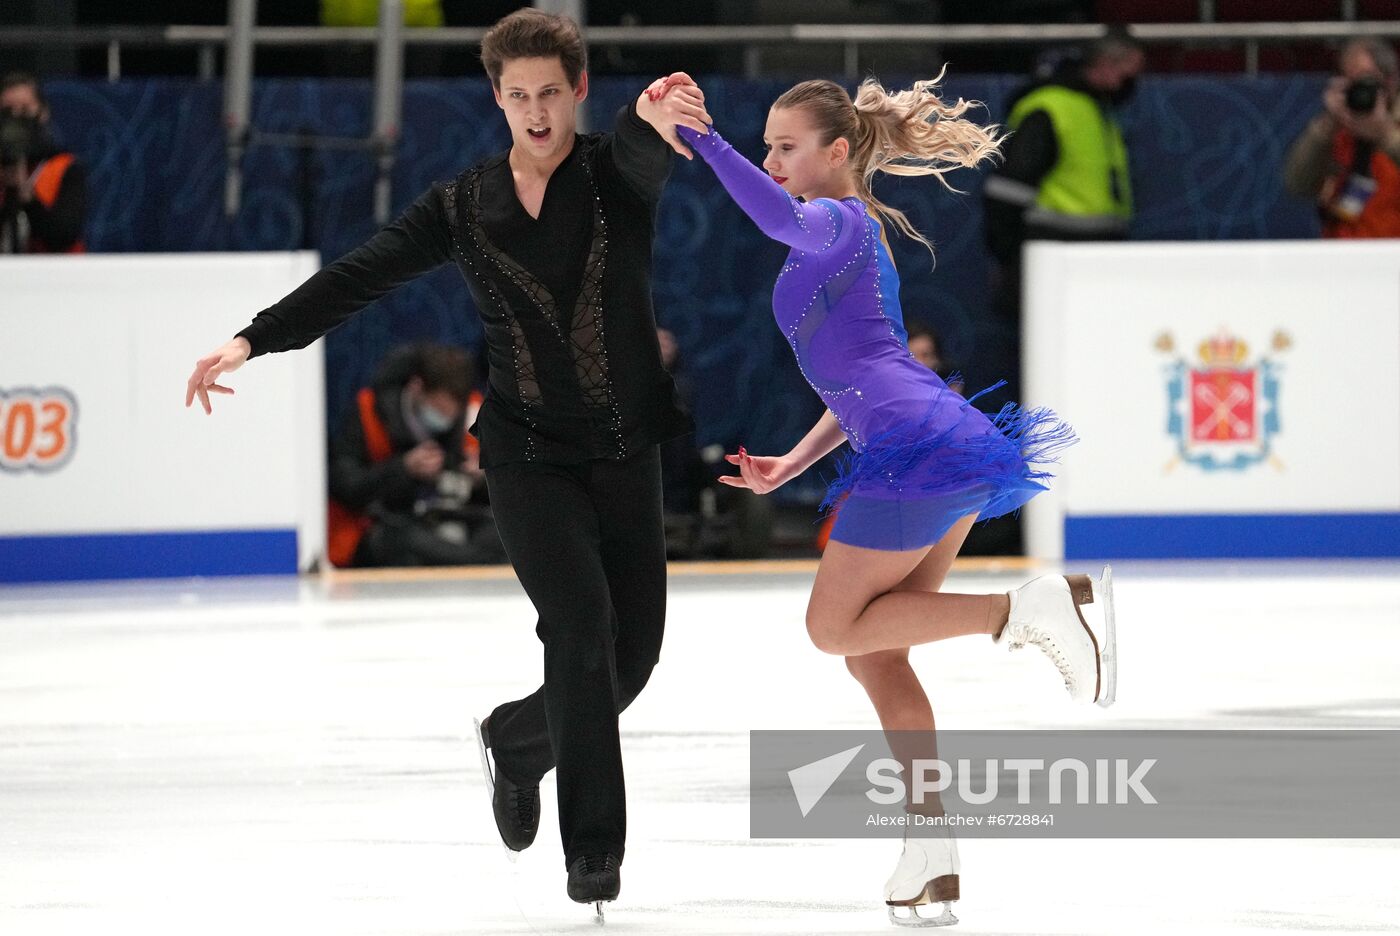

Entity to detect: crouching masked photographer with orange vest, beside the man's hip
[328,344,505,567]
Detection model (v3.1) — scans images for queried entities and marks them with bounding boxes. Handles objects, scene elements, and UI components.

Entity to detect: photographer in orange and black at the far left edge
[0,73,87,253]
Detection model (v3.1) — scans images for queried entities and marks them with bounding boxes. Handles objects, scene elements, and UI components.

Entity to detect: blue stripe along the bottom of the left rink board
[0,530,297,582]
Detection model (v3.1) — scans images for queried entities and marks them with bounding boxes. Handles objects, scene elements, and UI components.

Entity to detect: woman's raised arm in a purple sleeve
[676,126,841,253]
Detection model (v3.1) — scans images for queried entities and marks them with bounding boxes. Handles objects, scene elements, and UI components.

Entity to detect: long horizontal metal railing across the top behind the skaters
[8,21,1400,81]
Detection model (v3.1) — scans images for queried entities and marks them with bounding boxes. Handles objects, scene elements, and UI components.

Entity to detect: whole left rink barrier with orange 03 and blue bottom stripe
[0,252,326,582]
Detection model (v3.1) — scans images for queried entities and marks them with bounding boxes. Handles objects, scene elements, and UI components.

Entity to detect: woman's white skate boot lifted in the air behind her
[994,565,1119,708]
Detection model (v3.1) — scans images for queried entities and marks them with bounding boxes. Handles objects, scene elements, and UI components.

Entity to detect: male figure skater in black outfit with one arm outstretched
[185,10,710,915]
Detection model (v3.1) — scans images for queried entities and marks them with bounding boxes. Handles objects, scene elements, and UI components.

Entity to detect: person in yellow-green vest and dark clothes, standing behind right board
[983,28,1147,403]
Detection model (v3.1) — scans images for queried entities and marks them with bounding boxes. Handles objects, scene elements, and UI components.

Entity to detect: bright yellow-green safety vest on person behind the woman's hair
[1007,84,1133,220]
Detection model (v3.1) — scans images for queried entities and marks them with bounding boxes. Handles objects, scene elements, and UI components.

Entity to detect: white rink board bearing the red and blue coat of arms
[1023,241,1400,558]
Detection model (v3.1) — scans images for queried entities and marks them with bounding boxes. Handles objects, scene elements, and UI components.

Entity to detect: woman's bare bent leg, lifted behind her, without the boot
[806,516,1011,656]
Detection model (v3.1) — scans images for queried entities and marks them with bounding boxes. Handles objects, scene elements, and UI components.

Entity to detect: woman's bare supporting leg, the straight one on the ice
[846,518,972,816]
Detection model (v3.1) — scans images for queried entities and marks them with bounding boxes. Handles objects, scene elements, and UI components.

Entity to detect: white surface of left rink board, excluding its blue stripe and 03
[0,252,325,571]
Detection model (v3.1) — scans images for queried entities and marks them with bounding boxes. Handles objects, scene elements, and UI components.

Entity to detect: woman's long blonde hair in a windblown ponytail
[773,69,1005,250]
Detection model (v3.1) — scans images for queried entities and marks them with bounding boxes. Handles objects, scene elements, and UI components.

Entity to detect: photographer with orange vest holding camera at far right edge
[1284,38,1400,238]
